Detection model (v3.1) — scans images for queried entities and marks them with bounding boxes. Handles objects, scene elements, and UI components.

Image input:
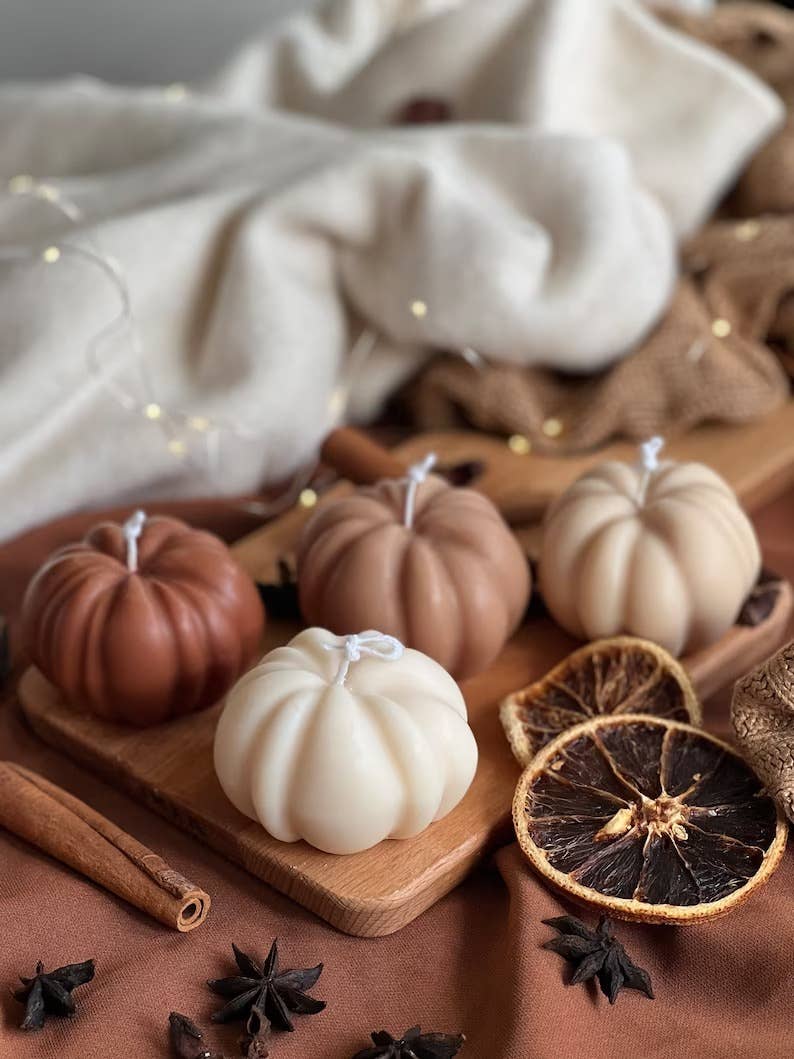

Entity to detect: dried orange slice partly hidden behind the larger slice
[500,636,702,766]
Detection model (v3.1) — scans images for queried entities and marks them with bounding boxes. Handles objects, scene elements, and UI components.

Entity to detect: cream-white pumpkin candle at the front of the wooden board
[215,628,477,854]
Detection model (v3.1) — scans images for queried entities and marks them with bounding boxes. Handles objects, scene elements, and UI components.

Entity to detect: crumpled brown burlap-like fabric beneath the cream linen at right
[401,216,794,454]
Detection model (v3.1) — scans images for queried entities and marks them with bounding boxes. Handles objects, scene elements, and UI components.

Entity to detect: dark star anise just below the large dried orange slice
[543,916,653,1004]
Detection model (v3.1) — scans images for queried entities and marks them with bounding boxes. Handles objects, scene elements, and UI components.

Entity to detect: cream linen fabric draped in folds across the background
[0,0,781,537]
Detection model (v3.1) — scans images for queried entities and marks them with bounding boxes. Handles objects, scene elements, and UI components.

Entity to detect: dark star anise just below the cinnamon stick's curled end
[207,941,325,1029]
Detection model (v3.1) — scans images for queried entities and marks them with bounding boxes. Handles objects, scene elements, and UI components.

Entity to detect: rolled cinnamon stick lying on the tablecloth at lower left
[0,761,210,932]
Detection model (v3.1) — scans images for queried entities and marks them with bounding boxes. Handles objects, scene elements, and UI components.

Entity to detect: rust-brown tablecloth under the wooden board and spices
[0,492,794,1059]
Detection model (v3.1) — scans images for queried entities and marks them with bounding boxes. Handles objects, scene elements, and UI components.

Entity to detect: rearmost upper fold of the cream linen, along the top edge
[210,0,783,234]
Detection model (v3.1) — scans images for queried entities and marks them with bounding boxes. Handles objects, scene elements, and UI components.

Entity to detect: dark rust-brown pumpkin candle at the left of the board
[22,511,264,726]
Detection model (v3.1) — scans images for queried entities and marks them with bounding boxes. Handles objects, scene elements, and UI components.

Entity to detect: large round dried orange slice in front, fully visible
[512,716,787,923]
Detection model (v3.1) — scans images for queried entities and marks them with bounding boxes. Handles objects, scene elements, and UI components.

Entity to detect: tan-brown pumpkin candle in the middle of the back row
[297,454,530,679]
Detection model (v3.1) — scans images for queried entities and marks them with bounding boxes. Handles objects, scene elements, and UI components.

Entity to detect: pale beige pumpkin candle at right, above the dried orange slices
[539,438,761,654]
